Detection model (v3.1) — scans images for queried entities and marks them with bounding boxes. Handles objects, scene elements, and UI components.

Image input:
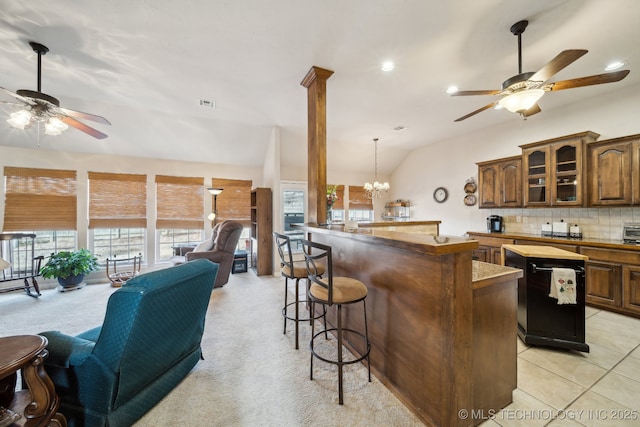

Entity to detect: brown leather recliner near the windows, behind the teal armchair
[171,219,243,288]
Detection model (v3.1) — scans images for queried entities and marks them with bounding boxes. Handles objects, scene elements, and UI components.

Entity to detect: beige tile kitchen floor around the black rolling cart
[482,307,640,427]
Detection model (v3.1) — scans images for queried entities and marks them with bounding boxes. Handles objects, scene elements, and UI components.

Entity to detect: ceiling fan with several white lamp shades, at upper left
[0,42,111,139]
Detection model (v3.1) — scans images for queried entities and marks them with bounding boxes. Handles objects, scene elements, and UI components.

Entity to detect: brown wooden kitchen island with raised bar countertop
[300,224,522,426]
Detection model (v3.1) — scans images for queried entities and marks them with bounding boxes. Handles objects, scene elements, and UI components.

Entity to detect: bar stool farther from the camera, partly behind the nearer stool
[273,232,326,350]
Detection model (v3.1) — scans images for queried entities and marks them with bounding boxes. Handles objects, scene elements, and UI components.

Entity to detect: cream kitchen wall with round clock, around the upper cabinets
[390,85,640,235]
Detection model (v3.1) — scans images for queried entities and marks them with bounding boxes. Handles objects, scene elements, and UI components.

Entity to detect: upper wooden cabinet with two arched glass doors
[520,131,600,207]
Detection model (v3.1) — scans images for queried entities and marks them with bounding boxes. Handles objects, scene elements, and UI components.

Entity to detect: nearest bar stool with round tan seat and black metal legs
[302,240,371,405]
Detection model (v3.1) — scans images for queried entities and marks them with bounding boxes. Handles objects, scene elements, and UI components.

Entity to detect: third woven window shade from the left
[156,175,204,230]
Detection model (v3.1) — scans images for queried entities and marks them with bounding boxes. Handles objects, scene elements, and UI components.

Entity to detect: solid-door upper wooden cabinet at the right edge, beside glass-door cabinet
[587,135,640,206]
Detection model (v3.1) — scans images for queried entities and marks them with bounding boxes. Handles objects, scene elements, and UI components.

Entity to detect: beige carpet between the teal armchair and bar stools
[0,272,423,427]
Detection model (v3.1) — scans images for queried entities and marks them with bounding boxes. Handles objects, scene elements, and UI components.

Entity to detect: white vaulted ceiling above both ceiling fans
[0,0,640,174]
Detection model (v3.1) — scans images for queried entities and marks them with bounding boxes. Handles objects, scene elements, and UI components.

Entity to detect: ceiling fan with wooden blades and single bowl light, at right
[451,21,629,122]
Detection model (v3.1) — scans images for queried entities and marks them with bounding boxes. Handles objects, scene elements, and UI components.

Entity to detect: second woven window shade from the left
[89,172,147,228]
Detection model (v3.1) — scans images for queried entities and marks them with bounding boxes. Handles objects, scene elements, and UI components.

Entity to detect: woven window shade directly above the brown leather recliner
[211,178,252,227]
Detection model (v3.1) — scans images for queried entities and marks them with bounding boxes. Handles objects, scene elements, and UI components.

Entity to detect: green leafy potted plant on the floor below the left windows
[40,249,98,287]
